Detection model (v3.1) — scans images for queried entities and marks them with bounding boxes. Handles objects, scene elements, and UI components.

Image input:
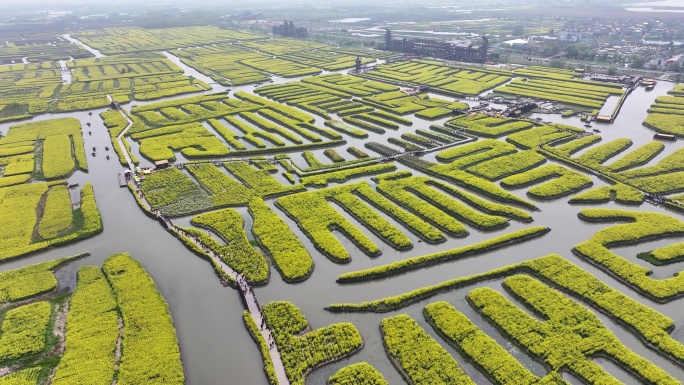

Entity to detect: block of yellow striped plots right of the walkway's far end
[129,92,342,154]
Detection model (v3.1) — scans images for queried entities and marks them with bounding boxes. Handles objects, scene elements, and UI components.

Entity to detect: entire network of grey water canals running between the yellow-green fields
[0,36,684,385]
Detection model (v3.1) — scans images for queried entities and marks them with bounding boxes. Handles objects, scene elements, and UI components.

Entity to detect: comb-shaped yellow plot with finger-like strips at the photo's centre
[276,173,531,263]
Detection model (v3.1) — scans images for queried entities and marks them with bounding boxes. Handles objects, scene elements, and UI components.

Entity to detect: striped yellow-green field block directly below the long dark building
[364,60,512,96]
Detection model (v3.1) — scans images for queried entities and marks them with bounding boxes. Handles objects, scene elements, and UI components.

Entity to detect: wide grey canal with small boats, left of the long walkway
[0,111,267,385]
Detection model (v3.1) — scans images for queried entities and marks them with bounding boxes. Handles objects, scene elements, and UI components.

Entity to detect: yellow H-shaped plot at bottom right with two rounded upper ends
[468,276,678,384]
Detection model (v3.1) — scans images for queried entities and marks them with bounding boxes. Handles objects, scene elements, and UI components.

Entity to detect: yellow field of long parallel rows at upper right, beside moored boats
[494,76,623,109]
